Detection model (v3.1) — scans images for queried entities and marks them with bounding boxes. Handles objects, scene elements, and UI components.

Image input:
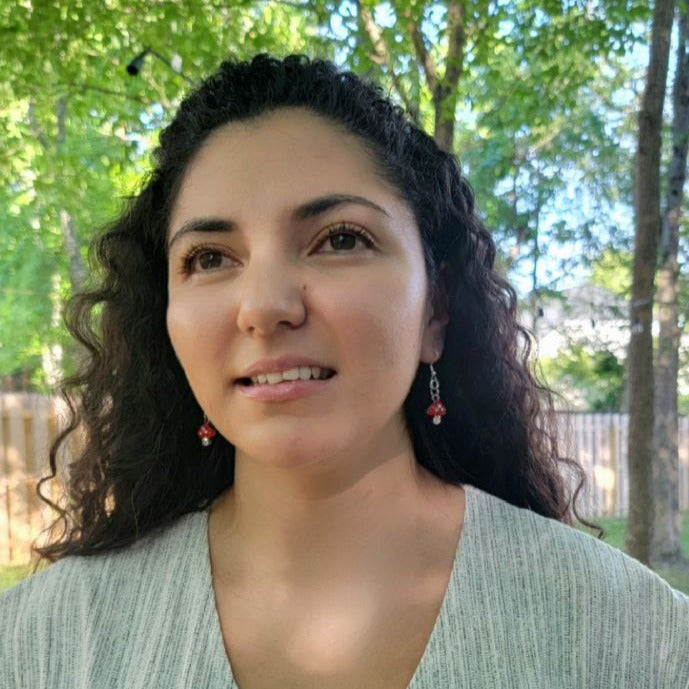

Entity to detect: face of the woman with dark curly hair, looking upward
[167,109,446,466]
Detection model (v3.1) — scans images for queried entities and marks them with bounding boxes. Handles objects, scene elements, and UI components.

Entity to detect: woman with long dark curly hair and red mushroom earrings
[0,55,689,689]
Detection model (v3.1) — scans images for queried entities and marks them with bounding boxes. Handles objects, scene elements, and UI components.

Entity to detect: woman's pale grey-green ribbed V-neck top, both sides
[0,486,689,689]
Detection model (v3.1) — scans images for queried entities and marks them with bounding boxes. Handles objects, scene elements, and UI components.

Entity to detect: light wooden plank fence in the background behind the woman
[0,393,689,563]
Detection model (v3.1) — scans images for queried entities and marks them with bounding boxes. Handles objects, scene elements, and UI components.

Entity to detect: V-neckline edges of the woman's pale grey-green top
[201,484,477,689]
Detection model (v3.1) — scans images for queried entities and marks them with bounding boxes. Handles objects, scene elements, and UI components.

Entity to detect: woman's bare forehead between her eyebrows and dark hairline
[171,108,404,226]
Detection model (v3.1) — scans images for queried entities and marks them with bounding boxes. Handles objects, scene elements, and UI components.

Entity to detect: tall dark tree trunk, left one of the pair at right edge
[625,0,674,564]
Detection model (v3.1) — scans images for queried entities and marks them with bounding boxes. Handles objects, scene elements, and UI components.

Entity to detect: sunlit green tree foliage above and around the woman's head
[0,0,668,398]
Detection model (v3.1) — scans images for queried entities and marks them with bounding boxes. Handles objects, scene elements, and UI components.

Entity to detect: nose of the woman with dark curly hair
[237,255,306,337]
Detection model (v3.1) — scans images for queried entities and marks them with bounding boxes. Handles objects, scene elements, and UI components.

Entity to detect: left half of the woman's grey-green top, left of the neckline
[0,512,233,689]
